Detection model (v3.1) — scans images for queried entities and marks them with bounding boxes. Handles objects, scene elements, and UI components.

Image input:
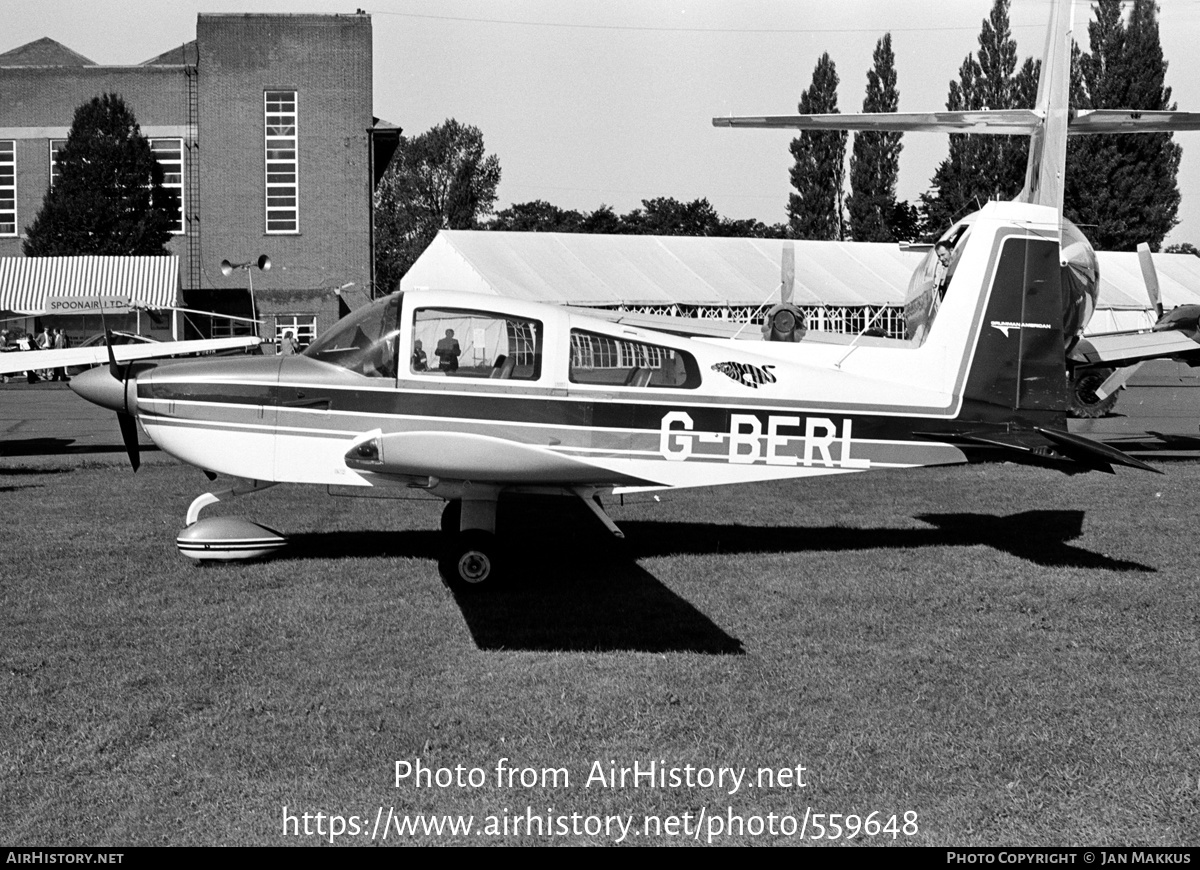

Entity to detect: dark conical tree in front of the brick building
[23,94,179,257]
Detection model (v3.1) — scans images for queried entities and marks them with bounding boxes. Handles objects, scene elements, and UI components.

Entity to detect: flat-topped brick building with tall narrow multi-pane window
[0,12,400,343]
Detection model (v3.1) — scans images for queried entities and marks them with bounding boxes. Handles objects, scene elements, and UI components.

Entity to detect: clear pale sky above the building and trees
[7,0,1200,245]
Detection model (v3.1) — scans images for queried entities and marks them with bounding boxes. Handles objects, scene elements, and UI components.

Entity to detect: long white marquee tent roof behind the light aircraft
[401,229,1200,311]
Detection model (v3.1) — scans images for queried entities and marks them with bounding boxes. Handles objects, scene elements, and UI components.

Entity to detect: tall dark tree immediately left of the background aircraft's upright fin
[920,0,1039,234]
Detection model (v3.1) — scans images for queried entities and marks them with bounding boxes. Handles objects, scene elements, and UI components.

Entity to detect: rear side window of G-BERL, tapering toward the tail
[570,329,700,390]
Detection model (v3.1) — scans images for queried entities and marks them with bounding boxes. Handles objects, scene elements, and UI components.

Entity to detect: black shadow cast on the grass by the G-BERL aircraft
[276,501,1154,655]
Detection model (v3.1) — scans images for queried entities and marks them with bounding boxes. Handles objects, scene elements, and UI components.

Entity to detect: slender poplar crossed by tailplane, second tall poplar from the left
[846,34,902,241]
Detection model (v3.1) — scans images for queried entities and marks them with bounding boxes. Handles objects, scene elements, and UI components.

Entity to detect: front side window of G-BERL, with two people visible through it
[409,308,542,380]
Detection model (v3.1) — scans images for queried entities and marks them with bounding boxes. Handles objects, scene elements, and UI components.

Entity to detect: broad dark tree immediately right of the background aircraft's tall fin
[1066,0,1182,251]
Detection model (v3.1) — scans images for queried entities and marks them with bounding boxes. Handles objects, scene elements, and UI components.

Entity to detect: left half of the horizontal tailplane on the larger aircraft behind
[713,109,1042,136]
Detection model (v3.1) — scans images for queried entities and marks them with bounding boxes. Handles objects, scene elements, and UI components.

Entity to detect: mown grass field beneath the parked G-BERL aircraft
[0,454,1200,846]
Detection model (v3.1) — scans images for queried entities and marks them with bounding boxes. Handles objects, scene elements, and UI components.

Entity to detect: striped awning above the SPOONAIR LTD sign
[0,257,179,316]
